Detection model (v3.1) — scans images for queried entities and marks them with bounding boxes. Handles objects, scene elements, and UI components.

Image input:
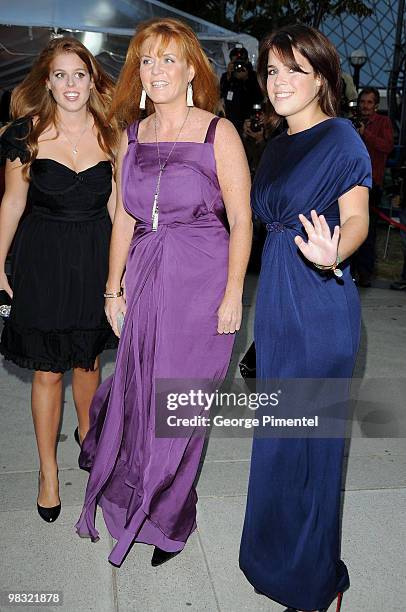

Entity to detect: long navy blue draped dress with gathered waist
[240,118,371,610]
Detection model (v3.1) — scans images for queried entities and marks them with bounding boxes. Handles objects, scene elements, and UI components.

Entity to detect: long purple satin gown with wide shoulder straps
[76,118,234,565]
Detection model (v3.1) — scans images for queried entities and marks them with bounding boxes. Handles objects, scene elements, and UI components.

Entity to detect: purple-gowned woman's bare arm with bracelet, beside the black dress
[105,132,135,336]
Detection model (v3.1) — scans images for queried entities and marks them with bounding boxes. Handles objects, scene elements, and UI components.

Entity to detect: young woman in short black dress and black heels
[0,38,118,522]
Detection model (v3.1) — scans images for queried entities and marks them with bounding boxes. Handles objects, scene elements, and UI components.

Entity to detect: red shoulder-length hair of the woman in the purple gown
[111,18,219,127]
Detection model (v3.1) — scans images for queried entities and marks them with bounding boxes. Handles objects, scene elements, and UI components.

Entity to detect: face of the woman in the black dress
[46,53,93,112]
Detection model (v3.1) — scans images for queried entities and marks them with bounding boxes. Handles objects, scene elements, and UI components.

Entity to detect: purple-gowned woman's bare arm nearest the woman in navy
[214,119,252,333]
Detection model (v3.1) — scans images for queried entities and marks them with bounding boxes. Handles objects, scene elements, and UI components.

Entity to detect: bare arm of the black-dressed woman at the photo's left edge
[0,159,29,297]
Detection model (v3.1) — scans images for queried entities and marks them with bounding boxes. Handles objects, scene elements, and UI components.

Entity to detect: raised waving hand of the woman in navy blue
[295,210,340,266]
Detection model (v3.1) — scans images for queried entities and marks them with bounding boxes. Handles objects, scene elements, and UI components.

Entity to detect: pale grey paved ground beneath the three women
[0,278,406,612]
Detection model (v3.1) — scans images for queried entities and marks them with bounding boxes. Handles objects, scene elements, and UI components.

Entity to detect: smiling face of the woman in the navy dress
[267,48,321,120]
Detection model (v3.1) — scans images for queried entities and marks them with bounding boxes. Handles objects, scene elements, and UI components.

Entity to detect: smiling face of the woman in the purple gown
[140,38,195,105]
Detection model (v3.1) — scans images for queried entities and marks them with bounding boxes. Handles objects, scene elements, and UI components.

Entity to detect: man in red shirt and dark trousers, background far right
[352,87,393,287]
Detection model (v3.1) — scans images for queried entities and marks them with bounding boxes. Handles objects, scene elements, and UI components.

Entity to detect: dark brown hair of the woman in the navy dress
[257,24,341,127]
